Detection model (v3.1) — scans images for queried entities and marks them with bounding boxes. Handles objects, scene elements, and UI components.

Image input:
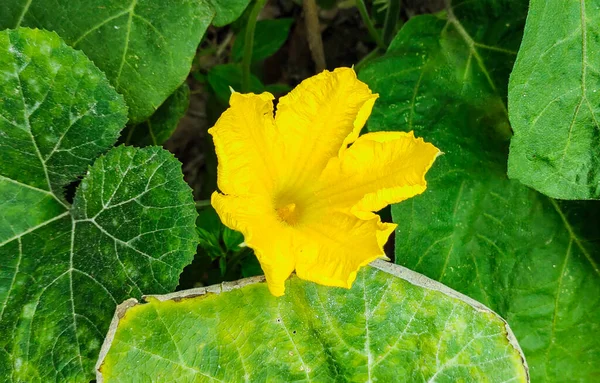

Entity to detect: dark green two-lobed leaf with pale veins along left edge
[0,28,196,382]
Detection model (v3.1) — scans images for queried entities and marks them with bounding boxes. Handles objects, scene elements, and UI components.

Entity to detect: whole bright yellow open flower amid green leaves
[209,68,440,296]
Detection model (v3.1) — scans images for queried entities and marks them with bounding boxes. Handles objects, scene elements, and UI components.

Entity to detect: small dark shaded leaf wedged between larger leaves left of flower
[122,83,190,147]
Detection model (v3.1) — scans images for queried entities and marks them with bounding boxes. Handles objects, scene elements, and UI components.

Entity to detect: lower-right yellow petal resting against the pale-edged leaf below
[296,210,396,288]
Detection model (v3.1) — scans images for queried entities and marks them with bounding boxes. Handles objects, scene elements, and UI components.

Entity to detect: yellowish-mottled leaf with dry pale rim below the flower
[97,261,527,383]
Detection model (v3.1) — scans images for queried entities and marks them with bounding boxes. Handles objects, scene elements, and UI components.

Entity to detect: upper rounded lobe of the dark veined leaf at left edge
[0,29,127,200]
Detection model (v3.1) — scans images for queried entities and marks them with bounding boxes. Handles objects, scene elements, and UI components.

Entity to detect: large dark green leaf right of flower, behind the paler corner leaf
[360,1,600,382]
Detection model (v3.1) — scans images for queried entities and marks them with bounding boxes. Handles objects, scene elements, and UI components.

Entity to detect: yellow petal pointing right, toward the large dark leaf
[316,132,440,219]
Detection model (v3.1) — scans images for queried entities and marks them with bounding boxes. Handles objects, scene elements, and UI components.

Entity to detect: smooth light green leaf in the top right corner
[508,0,600,199]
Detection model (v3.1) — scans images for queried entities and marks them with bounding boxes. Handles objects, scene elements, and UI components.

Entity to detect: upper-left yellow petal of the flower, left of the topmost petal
[208,93,280,195]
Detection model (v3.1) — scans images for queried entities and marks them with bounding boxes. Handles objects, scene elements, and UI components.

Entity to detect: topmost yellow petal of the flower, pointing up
[275,68,378,187]
